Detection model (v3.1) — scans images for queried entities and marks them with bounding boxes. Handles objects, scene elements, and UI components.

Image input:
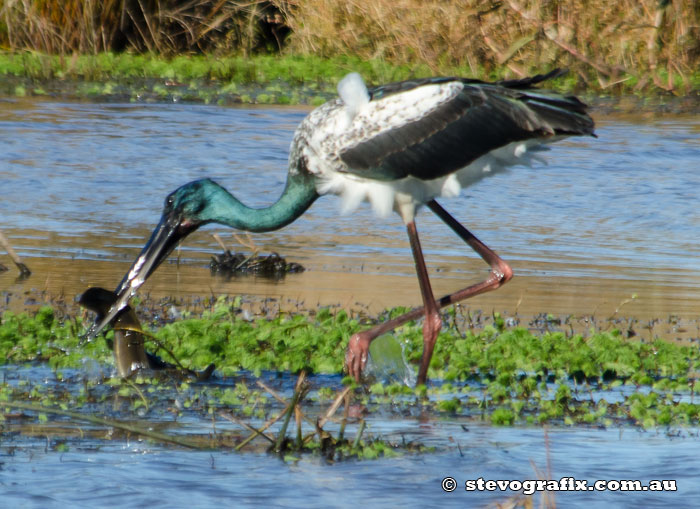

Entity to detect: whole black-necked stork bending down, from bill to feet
[88,70,594,383]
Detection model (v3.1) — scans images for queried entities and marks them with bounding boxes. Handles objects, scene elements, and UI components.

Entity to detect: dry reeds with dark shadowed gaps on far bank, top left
[0,0,286,55]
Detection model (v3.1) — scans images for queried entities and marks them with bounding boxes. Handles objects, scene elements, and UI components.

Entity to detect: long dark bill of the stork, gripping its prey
[85,210,198,341]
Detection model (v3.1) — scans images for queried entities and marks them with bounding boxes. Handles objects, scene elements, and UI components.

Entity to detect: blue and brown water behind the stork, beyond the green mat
[0,100,700,324]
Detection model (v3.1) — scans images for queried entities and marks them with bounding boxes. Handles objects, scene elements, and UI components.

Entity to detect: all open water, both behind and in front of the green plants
[0,95,700,508]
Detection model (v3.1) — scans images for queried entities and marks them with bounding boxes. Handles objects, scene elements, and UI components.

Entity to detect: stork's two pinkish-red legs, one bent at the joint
[345,200,513,384]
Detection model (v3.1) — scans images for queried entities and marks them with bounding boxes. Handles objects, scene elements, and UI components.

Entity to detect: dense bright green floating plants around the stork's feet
[0,299,700,428]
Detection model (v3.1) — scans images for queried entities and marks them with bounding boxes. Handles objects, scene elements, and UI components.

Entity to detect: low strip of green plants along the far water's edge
[0,51,700,109]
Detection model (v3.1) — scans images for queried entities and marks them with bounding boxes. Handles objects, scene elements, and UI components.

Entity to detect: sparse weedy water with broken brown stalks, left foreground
[0,366,431,461]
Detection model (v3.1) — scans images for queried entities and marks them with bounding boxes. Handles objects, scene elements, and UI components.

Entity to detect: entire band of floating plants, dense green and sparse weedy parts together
[0,298,700,461]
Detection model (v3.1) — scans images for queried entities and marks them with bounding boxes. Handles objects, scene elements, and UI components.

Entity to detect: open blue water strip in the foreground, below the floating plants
[0,422,700,508]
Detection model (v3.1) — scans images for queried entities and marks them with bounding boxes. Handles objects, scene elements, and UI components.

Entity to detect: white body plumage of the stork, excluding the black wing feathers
[290,73,561,223]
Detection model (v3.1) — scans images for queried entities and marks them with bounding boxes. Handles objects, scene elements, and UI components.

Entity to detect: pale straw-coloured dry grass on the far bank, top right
[276,0,700,90]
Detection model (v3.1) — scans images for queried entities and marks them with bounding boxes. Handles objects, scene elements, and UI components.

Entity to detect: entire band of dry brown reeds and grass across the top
[0,0,700,92]
